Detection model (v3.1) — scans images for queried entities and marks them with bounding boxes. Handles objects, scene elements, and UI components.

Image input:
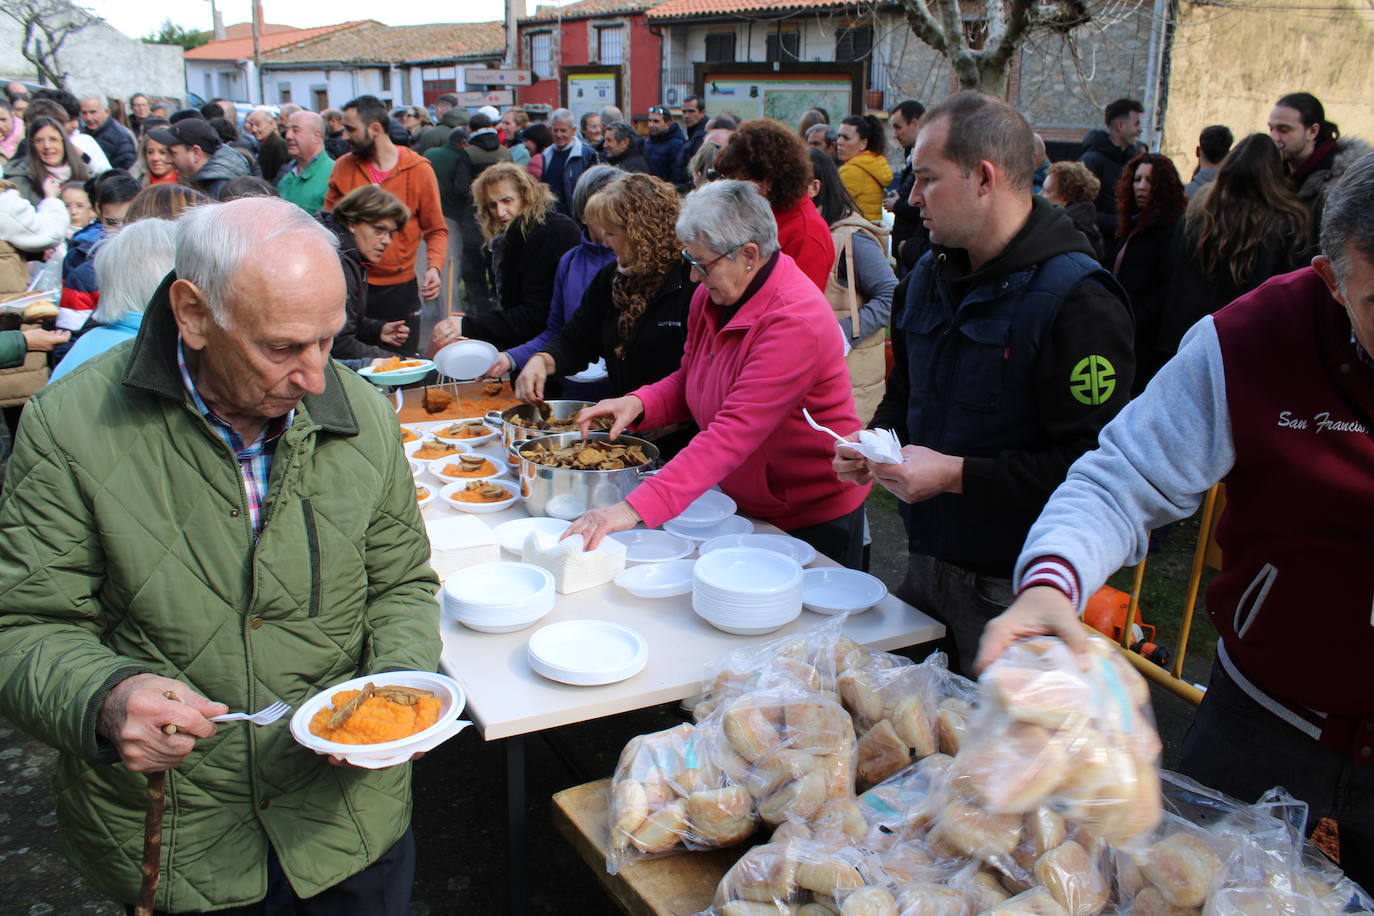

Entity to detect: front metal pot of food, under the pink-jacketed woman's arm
[510,433,658,519]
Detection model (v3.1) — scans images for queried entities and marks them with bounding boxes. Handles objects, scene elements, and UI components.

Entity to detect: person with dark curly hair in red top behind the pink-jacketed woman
[716,118,835,291]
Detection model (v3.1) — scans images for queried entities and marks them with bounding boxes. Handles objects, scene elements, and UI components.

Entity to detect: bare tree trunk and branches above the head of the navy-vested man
[903,0,1092,96]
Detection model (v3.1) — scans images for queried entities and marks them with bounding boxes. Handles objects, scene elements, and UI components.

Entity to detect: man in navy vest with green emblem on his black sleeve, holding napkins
[835,92,1135,670]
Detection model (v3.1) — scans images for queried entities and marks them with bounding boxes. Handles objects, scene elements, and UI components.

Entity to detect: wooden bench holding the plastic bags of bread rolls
[554,779,750,916]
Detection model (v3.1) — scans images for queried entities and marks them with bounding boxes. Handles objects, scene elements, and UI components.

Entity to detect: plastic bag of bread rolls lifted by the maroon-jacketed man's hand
[955,636,1161,845]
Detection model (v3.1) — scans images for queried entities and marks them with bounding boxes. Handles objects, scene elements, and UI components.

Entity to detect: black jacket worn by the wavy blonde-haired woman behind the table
[463,210,585,351]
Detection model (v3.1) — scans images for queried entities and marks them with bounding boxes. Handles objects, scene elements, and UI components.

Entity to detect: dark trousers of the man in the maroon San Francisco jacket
[1179,662,1374,893]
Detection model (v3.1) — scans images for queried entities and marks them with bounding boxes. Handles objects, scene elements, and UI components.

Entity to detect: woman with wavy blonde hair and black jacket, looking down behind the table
[430,162,581,350]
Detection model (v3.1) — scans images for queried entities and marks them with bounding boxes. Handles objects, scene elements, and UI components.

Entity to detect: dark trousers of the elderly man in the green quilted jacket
[125,829,415,916]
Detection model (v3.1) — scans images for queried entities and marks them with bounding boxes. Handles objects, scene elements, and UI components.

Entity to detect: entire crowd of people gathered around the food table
[0,73,1374,913]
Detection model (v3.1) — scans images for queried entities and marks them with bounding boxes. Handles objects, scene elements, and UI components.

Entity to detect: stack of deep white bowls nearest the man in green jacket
[444,563,554,633]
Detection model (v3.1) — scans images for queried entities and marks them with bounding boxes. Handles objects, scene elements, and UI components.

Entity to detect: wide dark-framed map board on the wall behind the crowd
[702,71,853,124]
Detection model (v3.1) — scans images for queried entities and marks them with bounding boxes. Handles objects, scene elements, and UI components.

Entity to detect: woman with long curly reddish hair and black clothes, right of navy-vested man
[1110,152,1189,394]
